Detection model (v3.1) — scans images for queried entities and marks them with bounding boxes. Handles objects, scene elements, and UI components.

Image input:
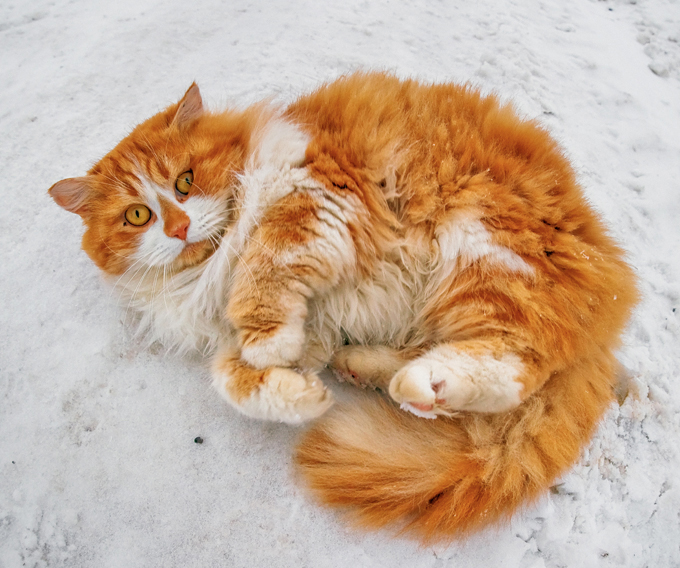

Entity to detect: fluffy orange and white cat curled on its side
[49,72,637,542]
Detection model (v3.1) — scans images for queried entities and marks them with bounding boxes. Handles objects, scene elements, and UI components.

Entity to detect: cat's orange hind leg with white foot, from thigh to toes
[389,243,606,417]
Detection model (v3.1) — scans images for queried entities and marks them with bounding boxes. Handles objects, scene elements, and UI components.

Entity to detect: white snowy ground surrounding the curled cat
[0,0,680,568]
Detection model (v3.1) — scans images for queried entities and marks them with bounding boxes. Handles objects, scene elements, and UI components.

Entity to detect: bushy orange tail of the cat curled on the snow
[296,352,615,542]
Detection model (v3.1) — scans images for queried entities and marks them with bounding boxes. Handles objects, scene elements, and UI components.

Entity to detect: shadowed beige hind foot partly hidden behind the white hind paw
[331,345,411,391]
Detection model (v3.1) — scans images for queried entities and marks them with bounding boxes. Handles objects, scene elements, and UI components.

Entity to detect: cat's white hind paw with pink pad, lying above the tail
[389,346,523,418]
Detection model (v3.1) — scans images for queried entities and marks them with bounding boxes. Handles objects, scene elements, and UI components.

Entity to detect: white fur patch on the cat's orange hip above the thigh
[435,213,534,274]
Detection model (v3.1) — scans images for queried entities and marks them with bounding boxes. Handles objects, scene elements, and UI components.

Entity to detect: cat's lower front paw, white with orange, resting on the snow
[213,364,333,424]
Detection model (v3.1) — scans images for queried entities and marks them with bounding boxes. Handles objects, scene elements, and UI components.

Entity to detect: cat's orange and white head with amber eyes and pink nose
[49,84,252,274]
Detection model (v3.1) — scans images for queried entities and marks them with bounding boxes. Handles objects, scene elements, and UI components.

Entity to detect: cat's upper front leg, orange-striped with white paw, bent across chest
[227,187,356,369]
